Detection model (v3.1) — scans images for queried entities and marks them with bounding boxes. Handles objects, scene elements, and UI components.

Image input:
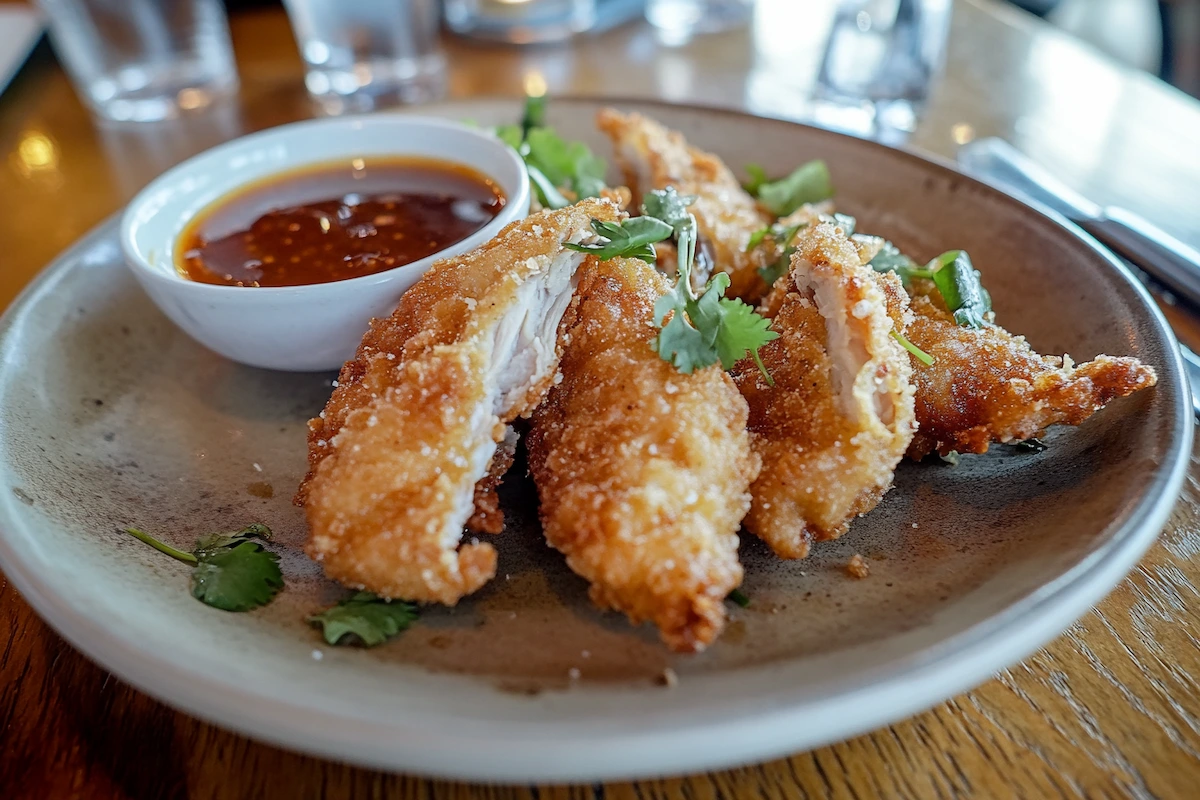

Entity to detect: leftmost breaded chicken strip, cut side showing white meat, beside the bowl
[300,200,619,604]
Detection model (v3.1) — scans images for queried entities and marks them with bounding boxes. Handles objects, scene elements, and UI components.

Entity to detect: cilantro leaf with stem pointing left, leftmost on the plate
[125,523,283,612]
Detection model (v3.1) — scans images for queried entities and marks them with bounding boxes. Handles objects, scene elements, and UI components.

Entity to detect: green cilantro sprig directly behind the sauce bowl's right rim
[494,95,607,209]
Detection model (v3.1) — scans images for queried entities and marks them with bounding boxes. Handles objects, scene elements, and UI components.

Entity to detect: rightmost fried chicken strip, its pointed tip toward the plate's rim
[902,281,1158,459]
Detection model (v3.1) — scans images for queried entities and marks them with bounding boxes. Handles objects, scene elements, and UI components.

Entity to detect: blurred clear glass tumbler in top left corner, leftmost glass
[38,0,238,121]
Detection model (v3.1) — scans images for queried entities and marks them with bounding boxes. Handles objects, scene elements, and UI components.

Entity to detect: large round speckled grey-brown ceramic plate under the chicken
[0,101,1192,782]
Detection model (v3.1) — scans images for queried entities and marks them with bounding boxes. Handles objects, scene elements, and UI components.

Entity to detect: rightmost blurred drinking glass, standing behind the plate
[812,0,950,143]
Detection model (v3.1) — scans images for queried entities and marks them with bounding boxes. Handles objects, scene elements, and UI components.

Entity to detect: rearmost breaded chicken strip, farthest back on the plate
[596,108,773,303]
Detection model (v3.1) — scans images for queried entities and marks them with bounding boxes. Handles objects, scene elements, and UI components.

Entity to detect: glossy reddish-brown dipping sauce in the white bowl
[175,158,504,287]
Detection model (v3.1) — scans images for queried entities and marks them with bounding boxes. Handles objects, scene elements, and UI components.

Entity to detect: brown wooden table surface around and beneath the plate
[0,0,1200,798]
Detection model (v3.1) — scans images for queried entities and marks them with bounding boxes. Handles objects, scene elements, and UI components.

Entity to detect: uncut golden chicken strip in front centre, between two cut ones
[527,259,758,651]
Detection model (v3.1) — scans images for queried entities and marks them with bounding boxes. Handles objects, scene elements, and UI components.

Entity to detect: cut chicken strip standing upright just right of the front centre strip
[733,223,916,558]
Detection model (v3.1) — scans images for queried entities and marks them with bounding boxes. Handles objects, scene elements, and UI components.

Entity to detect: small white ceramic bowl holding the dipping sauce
[121,114,529,372]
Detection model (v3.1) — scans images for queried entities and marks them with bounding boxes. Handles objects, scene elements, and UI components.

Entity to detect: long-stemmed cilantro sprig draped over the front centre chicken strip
[642,188,779,385]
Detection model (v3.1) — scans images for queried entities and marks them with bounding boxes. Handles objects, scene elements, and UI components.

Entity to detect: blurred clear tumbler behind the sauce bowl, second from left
[283,0,445,114]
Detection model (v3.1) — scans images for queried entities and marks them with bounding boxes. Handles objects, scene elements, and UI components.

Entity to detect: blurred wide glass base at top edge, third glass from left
[445,0,604,44]
